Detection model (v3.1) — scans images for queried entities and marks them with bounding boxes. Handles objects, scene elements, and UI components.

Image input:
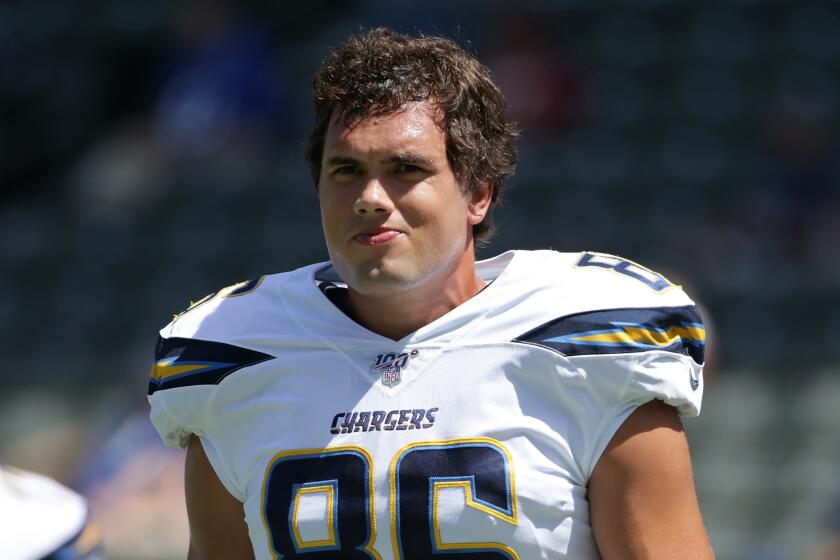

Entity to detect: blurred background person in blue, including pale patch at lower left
[69,0,286,222]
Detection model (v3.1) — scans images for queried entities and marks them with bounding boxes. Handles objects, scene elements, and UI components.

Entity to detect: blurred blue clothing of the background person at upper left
[153,0,288,162]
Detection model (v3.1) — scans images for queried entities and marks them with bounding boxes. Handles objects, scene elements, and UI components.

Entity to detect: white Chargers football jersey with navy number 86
[149,251,705,560]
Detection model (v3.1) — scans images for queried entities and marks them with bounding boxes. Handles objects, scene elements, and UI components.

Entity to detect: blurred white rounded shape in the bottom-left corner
[0,466,97,560]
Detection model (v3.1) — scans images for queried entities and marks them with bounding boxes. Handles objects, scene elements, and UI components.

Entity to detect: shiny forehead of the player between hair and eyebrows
[324,101,446,157]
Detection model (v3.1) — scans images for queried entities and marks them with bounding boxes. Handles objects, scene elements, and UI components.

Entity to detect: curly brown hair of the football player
[306,27,518,243]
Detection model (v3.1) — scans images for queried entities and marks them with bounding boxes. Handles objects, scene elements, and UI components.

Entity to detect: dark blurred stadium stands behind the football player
[0,0,840,560]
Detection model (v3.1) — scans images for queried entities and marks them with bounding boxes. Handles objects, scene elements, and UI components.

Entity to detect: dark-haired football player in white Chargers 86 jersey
[149,29,712,560]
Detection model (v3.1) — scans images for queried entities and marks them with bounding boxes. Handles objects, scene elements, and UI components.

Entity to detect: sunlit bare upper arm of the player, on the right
[589,400,714,560]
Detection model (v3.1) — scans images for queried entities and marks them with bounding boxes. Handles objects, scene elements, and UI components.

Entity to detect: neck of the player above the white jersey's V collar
[349,251,486,340]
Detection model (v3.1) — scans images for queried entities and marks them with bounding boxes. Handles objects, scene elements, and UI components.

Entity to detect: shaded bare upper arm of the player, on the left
[185,436,254,560]
